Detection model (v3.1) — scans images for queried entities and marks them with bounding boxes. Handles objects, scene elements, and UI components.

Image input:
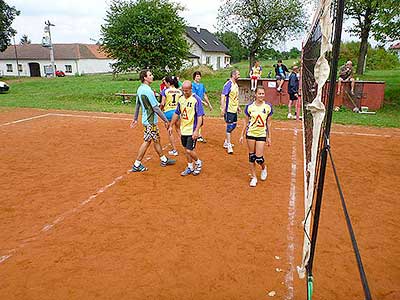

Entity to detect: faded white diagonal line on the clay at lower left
[0,175,124,264]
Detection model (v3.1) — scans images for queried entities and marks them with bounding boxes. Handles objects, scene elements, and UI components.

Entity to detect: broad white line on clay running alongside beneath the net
[285,127,298,300]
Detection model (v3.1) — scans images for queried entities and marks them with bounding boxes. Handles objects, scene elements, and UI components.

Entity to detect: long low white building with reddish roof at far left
[0,44,115,77]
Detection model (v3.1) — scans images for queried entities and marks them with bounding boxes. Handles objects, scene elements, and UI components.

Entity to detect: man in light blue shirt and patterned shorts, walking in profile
[131,69,176,172]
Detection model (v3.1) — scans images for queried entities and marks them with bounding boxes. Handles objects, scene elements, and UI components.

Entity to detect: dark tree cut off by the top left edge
[0,0,20,52]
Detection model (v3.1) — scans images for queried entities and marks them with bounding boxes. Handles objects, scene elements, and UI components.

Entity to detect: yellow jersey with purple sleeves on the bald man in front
[175,94,204,136]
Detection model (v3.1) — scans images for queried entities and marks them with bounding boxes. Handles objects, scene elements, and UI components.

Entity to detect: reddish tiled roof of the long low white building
[0,44,108,60]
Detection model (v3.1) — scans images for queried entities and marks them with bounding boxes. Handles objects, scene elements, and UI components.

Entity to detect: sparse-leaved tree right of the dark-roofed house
[218,0,305,65]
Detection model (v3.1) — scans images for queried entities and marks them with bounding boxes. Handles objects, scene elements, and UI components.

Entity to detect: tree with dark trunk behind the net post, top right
[345,0,400,75]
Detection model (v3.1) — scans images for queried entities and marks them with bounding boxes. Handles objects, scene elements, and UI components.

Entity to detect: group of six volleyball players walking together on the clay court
[131,69,273,187]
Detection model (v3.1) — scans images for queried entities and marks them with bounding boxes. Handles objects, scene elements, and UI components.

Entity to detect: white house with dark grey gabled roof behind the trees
[185,26,231,70]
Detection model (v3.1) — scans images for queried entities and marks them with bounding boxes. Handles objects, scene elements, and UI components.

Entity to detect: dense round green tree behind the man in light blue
[101,0,189,78]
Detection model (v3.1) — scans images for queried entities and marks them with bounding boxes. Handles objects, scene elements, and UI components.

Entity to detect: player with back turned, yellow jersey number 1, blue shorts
[160,76,182,156]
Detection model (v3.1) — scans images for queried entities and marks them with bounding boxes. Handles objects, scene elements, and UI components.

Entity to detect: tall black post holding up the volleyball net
[307,0,345,277]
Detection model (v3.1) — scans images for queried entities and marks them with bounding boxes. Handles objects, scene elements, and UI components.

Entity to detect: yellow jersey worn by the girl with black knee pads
[244,101,274,137]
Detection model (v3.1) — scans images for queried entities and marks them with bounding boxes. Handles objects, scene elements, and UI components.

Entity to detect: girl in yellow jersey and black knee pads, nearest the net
[239,87,273,187]
